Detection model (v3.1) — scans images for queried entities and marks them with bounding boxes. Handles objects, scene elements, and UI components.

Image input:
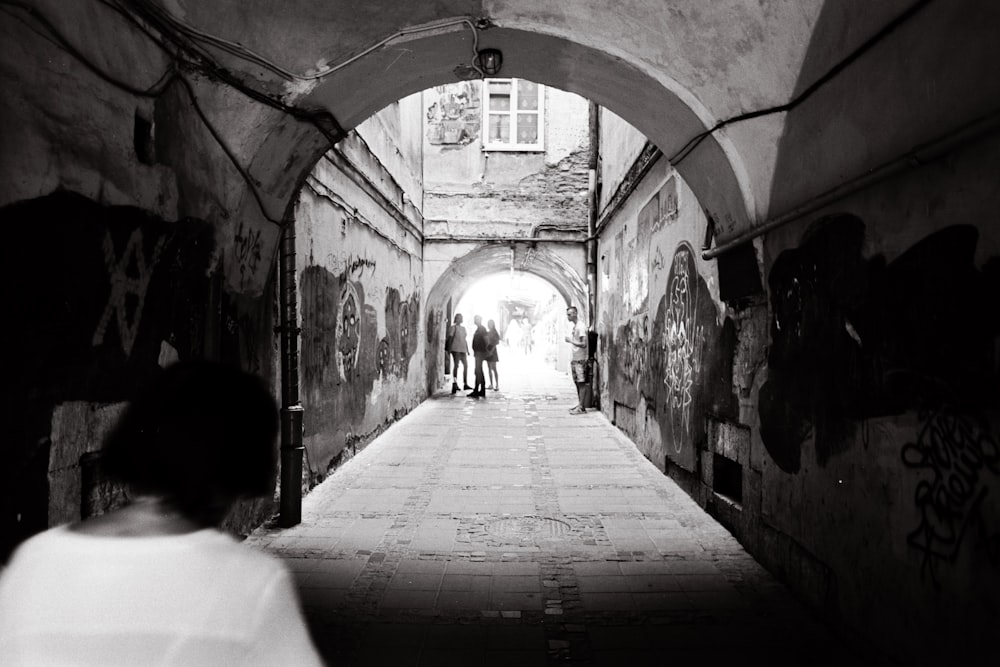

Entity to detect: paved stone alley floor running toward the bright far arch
[247,363,860,666]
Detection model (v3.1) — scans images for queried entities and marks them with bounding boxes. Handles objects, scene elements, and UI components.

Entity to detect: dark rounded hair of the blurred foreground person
[103,360,278,524]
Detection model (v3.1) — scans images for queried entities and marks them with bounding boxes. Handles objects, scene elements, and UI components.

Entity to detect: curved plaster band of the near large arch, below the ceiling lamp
[203,17,755,292]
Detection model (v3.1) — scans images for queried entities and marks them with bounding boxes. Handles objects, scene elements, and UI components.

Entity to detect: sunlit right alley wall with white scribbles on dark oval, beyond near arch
[597,147,736,472]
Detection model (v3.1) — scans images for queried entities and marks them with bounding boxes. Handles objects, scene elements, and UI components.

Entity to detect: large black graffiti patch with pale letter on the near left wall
[2,192,215,401]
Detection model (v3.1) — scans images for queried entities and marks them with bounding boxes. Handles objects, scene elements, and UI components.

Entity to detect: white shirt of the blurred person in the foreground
[0,526,322,667]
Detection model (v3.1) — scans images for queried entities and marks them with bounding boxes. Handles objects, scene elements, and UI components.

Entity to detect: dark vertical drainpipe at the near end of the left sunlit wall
[278,209,305,528]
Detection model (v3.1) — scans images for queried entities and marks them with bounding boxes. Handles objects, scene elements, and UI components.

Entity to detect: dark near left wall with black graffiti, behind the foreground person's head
[0,1,281,559]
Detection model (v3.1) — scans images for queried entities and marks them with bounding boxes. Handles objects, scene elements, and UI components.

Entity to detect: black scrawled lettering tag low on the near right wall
[902,406,1000,586]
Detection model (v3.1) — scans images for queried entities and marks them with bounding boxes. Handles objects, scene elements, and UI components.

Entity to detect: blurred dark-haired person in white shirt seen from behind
[0,361,322,665]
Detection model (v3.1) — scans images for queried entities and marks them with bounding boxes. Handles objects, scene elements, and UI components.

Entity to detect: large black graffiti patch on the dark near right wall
[758,215,1000,473]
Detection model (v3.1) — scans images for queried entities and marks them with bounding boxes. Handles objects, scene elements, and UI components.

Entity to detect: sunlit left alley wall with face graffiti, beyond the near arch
[296,126,425,484]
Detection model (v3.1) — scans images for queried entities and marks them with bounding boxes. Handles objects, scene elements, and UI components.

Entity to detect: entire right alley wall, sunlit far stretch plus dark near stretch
[598,111,1000,664]
